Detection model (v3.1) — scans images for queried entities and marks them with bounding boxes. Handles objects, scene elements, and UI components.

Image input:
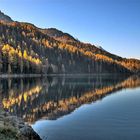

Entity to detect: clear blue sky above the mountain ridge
[0,0,140,59]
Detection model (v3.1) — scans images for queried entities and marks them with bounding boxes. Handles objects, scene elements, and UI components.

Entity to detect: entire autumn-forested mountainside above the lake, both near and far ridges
[0,10,140,74]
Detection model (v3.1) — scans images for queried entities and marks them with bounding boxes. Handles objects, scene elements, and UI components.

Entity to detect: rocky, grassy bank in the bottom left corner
[0,108,41,140]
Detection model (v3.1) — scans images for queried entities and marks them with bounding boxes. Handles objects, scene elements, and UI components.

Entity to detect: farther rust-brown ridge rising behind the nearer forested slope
[41,28,140,73]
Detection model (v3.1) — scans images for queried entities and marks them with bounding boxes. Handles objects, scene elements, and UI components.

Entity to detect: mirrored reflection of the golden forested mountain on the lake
[0,75,140,123]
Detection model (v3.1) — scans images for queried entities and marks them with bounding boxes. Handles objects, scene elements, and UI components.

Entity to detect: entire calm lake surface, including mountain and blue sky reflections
[0,75,140,140]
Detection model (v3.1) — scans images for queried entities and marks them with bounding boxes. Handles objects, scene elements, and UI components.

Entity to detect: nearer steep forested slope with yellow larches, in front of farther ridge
[0,22,130,73]
